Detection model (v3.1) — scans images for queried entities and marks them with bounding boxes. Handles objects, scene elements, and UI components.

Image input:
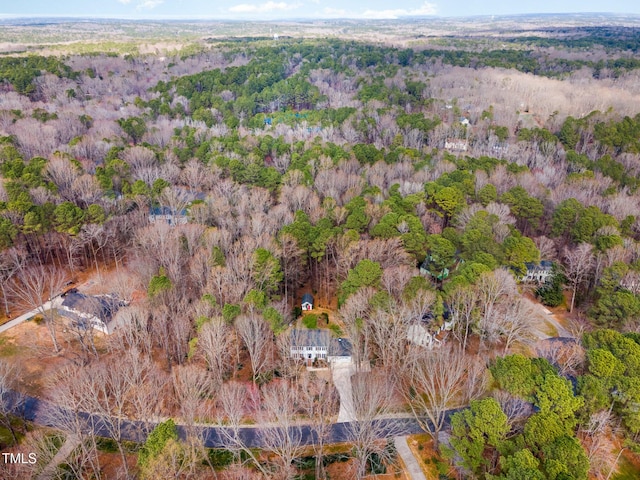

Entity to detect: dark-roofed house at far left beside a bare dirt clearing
[58,289,126,335]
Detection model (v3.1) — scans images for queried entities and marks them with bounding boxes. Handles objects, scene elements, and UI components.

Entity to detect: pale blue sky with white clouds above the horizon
[0,0,640,20]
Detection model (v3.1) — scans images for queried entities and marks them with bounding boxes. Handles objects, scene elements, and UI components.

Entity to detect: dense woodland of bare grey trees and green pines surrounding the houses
[0,21,640,480]
